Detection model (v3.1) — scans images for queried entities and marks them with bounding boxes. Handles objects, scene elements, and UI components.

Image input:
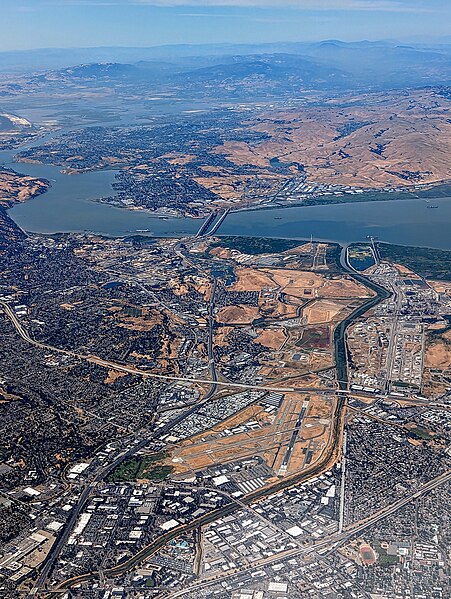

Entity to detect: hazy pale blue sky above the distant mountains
[0,0,451,50]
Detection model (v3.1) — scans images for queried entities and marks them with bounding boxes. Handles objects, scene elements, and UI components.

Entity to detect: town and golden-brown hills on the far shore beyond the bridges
[0,88,451,216]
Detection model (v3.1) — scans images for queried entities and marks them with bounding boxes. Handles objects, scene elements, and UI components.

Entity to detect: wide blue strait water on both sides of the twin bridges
[0,146,451,249]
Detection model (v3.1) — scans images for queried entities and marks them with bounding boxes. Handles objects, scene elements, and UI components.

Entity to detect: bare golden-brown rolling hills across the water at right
[216,90,451,188]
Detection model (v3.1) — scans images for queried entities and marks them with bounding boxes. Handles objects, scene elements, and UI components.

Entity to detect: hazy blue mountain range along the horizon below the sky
[0,40,451,95]
